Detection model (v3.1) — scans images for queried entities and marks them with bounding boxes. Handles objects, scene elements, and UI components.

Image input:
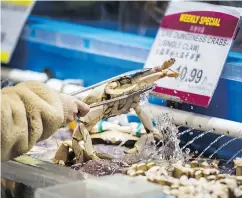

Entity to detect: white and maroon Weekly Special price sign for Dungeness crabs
[145,2,240,107]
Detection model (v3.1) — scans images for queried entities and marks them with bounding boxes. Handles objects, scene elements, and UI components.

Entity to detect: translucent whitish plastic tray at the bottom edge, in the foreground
[35,174,171,198]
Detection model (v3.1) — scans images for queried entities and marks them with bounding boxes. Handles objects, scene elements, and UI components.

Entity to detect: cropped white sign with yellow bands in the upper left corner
[1,0,35,63]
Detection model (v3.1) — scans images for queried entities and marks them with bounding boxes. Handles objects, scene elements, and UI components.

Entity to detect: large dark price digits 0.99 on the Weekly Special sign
[176,65,206,85]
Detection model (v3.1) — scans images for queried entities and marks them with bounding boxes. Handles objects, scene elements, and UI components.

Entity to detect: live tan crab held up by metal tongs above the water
[55,58,179,163]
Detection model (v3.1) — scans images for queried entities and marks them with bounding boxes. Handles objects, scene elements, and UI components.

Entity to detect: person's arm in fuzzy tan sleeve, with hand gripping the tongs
[1,81,89,161]
